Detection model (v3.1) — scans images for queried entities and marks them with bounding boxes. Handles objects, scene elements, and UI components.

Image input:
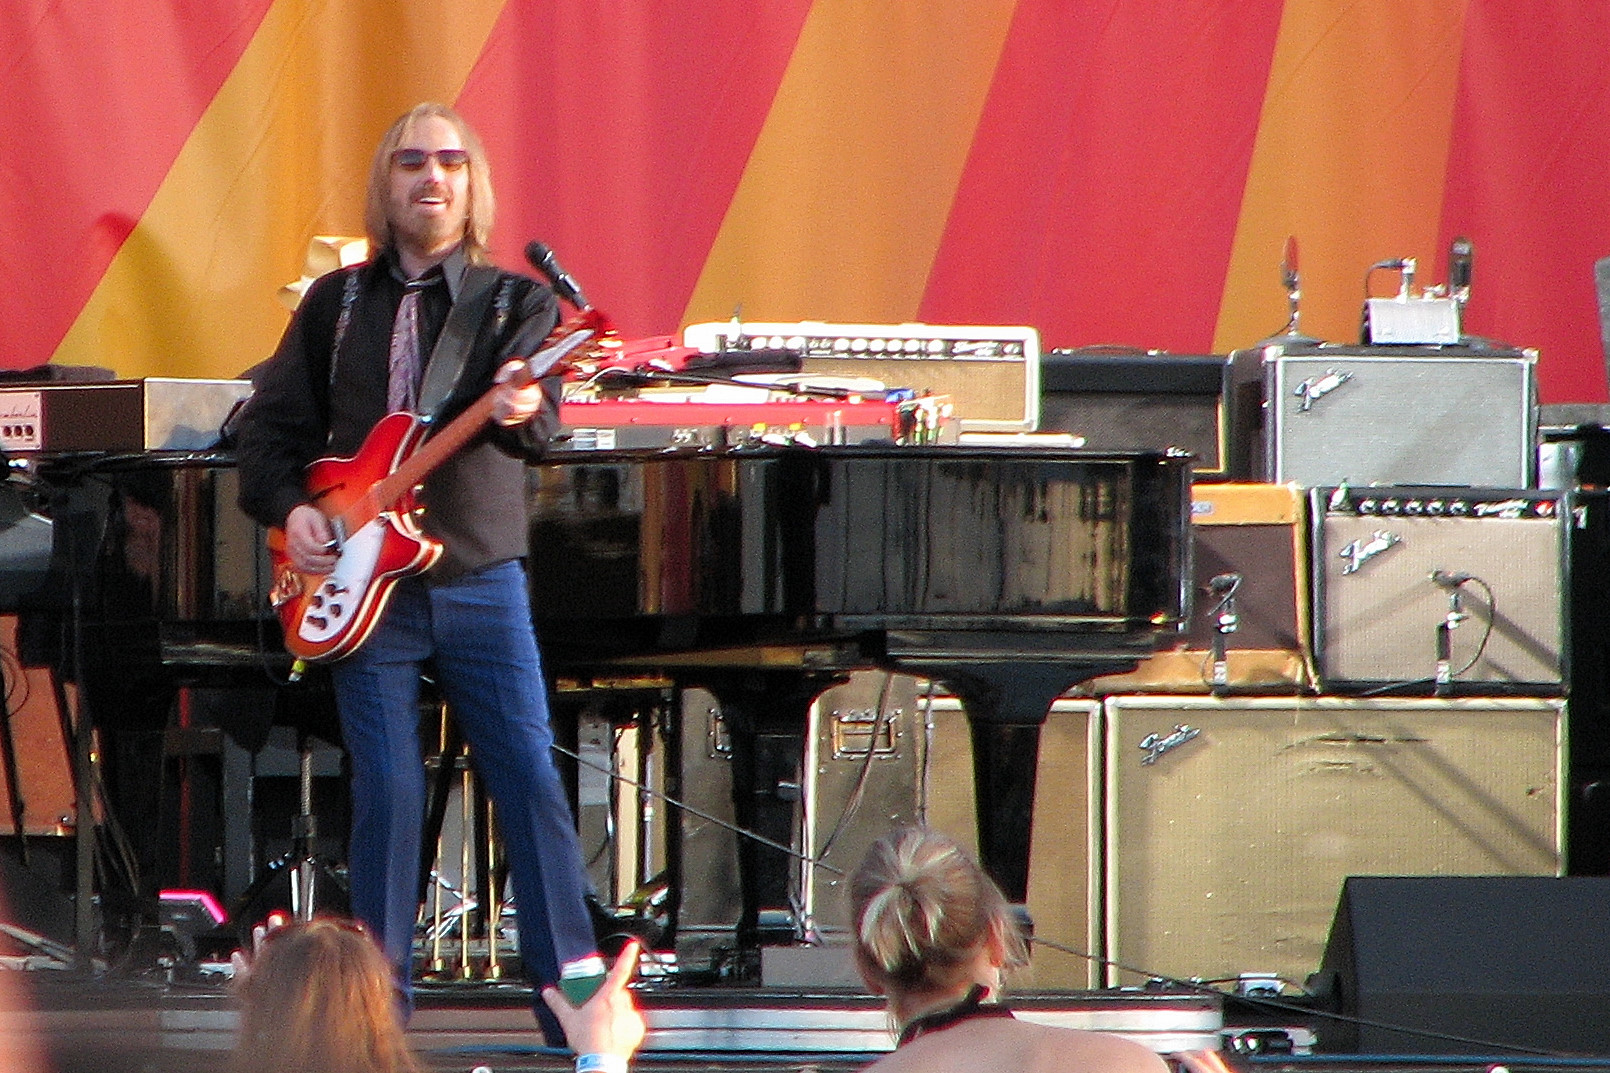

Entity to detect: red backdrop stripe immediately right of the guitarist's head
[460,0,810,335]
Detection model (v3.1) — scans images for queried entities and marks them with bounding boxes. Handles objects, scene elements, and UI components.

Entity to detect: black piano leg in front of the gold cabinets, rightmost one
[929,661,1135,905]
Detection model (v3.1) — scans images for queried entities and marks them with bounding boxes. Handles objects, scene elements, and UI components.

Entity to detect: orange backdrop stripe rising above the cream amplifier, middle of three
[686,0,1013,321]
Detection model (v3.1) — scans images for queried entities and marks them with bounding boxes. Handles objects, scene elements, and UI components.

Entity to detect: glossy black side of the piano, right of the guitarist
[531,445,1190,654]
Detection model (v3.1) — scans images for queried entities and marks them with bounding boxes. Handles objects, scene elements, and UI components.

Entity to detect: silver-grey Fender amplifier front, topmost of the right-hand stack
[1262,346,1538,488]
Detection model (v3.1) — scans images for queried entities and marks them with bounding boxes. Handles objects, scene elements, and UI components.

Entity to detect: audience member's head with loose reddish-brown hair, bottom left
[229,917,419,1073]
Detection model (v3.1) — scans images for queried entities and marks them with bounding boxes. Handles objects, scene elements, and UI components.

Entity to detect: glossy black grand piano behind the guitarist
[15,445,1191,939]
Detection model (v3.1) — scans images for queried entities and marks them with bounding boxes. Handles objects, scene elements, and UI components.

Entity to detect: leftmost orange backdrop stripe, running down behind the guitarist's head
[56,0,502,377]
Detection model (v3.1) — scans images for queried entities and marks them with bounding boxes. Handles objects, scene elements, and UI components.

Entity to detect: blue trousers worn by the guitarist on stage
[332,561,597,1042]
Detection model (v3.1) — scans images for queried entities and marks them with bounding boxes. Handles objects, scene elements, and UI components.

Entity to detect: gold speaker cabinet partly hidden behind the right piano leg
[923,696,1101,991]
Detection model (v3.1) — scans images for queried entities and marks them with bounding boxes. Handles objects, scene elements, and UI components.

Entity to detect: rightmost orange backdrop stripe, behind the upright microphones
[1214,0,1467,350]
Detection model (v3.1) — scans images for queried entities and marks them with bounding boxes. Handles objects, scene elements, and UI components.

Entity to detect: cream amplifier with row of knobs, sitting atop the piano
[683,321,1040,433]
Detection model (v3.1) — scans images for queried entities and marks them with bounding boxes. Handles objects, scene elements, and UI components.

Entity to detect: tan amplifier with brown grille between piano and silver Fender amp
[1079,483,1315,696]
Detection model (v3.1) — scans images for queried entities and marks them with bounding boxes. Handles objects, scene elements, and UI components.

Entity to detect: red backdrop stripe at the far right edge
[1435,0,1610,401]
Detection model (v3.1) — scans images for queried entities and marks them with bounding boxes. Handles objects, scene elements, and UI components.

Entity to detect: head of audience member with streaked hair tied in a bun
[850,827,1029,992]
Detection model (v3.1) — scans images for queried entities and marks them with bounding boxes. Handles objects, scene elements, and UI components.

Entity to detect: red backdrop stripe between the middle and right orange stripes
[921,0,1282,351]
